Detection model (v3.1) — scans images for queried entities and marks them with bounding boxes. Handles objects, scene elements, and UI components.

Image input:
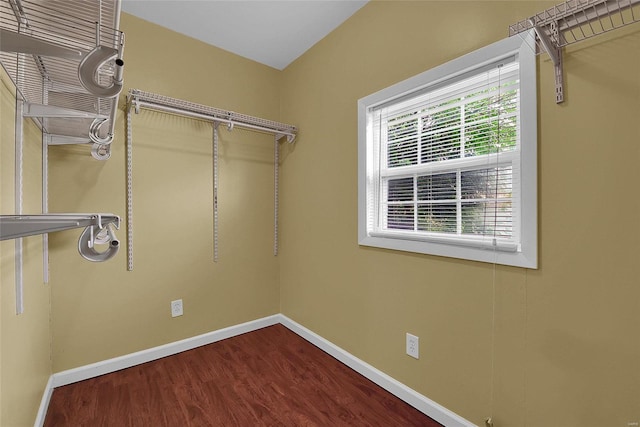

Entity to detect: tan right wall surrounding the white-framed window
[280,1,640,427]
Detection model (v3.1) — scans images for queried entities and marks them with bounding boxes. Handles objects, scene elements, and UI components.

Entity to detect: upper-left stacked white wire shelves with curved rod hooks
[0,0,124,160]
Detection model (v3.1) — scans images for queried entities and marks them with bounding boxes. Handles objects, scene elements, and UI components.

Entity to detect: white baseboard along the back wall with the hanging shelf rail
[53,315,280,387]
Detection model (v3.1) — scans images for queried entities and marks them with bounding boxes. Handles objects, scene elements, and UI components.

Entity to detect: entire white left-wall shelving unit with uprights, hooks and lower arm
[0,0,124,314]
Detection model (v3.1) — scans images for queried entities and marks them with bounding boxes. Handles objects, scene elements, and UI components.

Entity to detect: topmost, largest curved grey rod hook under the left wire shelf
[78,46,124,98]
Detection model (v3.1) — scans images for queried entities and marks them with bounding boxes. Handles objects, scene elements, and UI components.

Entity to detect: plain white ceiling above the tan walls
[122,0,368,70]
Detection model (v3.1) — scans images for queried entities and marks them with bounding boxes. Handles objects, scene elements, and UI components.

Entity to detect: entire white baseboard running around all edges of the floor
[40,314,476,427]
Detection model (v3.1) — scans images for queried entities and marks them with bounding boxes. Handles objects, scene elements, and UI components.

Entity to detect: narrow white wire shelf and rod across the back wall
[129,90,297,143]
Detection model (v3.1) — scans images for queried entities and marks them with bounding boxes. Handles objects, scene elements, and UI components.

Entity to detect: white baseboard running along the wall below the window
[279,314,476,427]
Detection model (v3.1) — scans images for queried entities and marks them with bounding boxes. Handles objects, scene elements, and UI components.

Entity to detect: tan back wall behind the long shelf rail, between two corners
[50,14,280,372]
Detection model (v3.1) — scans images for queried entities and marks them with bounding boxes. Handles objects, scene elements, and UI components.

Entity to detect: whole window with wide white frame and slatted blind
[358,35,537,268]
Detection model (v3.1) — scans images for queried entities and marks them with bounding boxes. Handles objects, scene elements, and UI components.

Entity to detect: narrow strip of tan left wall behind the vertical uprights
[0,70,51,427]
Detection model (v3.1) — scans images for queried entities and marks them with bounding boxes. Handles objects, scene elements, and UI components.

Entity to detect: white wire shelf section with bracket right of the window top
[509,0,640,104]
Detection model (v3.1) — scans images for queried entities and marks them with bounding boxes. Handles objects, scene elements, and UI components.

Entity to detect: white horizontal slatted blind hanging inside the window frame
[372,58,519,250]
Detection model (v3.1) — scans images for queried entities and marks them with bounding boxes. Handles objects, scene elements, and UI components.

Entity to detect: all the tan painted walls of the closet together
[0,1,640,427]
